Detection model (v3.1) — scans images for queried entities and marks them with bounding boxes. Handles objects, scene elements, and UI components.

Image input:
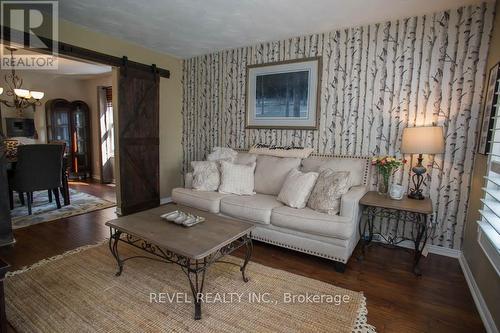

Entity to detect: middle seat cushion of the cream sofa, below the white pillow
[220,194,283,224]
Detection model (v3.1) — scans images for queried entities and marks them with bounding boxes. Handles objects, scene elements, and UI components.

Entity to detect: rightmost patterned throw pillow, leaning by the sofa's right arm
[307,169,351,215]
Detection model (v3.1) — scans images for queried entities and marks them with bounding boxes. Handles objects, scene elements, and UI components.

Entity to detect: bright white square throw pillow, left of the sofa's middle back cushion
[219,161,255,195]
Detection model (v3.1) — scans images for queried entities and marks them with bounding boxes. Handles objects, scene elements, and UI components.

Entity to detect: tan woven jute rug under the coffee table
[5,244,375,333]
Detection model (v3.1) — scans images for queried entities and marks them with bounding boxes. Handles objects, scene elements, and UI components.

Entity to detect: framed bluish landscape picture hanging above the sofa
[246,57,321,129]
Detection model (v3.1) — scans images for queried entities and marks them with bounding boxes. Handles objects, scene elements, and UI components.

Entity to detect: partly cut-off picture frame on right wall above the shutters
[477,63,500,155]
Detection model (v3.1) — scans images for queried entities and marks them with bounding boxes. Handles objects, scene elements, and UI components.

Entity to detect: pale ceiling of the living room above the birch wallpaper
[59,0,481,58]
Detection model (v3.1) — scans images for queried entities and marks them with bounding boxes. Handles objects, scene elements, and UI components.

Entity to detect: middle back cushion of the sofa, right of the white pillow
[255,155,300,195]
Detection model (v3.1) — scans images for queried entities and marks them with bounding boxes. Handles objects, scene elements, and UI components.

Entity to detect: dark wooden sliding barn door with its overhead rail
[0,27,170,214]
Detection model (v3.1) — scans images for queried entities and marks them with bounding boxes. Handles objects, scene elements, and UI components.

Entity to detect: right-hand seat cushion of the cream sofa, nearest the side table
[271,206,356,239]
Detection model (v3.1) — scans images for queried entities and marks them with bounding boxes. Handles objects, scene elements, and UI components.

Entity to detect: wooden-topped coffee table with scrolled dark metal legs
[106,204,254,320]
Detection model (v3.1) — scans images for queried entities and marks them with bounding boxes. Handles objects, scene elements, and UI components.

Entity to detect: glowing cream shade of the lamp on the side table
[401,126,444,154]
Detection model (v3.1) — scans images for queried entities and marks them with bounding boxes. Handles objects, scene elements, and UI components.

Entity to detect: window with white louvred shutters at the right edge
[478,80,500,275]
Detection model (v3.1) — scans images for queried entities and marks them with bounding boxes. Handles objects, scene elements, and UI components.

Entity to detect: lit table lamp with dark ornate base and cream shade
[401,126,444,200]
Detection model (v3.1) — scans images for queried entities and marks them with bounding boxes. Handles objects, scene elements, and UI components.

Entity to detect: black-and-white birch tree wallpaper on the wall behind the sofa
[183,3,494,249]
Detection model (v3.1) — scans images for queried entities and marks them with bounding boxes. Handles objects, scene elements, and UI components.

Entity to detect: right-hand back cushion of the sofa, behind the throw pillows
[300,156,370,186]
